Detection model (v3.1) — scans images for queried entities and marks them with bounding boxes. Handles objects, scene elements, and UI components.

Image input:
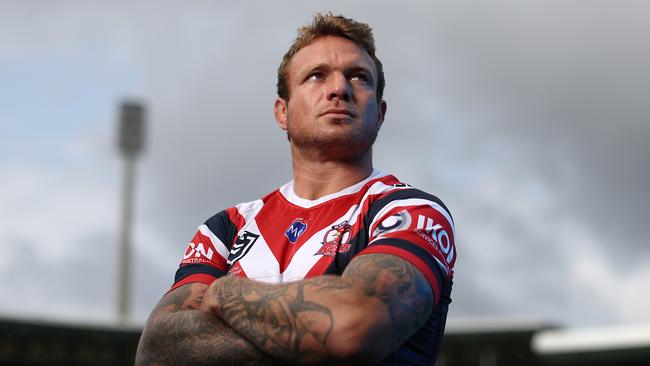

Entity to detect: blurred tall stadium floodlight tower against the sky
[117,100,145,325]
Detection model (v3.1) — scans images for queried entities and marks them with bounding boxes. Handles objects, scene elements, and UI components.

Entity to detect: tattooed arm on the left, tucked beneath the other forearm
[135,283,272,365]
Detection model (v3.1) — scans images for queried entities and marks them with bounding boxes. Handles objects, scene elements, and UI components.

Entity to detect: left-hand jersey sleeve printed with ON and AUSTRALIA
[169,209,237,291]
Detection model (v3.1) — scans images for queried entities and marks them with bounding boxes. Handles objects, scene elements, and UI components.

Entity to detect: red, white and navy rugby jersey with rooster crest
[172,172,456,363]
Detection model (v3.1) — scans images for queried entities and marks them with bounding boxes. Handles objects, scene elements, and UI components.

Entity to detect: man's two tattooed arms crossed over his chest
[136,254,434,365]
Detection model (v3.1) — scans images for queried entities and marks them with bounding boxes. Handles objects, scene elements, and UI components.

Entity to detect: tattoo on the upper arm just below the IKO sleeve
[343,254,434,349]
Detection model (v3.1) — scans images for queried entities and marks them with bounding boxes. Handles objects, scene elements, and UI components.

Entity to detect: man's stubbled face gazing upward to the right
[275,36,386,158]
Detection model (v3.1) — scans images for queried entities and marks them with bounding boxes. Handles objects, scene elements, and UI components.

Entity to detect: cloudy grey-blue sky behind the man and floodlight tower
[0,1,650,326]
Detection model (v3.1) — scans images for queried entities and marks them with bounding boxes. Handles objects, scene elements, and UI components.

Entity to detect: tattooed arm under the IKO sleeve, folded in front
[202,254,434,364]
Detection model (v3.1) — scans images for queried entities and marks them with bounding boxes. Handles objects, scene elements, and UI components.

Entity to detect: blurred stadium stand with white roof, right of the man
[436,319,650,366]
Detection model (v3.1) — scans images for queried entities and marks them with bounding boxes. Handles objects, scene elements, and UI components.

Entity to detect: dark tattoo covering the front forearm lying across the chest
[215,277,344,363]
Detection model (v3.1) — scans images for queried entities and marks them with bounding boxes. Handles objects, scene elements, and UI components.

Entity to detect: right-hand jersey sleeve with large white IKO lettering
[358,189,456,302]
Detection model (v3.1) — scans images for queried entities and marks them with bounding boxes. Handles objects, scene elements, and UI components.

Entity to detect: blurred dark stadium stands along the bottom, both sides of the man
[0,318,650,366]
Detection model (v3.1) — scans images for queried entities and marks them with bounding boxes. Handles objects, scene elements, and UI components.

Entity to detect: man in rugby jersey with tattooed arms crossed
[136,14,456,365]
